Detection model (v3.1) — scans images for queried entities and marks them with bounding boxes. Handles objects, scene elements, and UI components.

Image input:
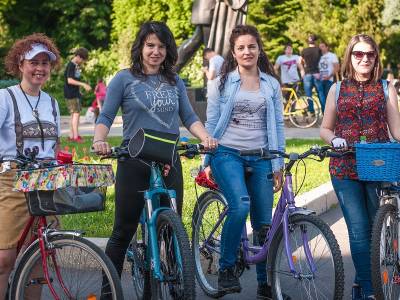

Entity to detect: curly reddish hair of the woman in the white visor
[4,33,60,77]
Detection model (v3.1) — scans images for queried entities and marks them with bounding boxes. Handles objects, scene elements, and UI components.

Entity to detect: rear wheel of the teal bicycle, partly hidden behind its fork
[126,222,151,299]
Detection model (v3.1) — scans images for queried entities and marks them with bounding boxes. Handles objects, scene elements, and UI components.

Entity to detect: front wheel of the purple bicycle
[268,215,344,300]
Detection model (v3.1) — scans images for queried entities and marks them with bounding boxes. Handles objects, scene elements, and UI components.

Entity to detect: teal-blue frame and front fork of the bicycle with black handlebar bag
[142,162,181,281]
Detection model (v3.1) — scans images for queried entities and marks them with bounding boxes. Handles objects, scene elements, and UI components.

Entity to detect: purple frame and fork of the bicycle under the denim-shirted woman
[202,172,316,277]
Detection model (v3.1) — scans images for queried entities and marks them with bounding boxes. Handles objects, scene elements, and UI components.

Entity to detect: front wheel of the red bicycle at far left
[10,235,123,300]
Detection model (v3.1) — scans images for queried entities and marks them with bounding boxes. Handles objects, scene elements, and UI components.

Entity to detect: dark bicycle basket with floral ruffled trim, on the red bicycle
[14,164,115,216]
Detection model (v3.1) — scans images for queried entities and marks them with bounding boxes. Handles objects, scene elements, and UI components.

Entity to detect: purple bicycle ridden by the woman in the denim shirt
[192,146,344,300]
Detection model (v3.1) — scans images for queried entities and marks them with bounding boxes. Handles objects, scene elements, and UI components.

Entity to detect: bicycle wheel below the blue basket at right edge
[371,204,400,300]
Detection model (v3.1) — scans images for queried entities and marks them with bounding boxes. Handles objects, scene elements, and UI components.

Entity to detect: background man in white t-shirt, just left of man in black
[274,44,304,100]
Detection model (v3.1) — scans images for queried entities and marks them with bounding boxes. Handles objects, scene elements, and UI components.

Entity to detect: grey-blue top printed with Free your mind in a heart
[97,69,199,140]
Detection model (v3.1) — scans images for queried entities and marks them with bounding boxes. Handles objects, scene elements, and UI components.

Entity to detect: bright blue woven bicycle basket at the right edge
[355,143,400,182]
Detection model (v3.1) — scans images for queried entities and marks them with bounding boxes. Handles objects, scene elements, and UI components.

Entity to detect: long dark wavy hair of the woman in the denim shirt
[219,25,279,91]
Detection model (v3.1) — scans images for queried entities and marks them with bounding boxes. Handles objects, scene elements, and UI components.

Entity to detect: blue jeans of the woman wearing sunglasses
[331,177,380,296]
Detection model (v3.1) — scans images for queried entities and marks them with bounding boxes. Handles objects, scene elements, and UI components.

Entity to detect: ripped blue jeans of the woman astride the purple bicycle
[211,145,273,283]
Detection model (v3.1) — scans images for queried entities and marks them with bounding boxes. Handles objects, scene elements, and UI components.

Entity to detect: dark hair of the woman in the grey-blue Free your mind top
[130,21,178,84]
